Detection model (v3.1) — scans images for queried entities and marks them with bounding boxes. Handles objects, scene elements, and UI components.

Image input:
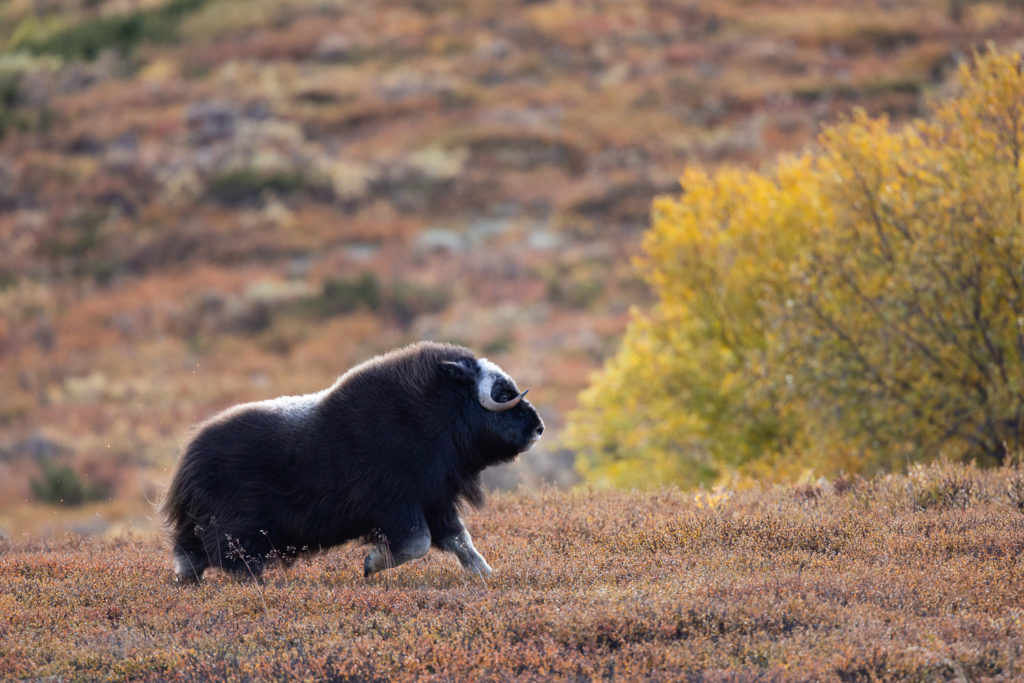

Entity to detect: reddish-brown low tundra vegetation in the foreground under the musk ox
[0,463,1024,681]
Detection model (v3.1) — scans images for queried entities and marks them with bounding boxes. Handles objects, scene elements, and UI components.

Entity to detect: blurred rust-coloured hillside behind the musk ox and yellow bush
[0,0,1024,533]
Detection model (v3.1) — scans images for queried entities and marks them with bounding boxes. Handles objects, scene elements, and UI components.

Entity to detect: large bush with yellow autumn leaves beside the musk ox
[568,49,1024,485]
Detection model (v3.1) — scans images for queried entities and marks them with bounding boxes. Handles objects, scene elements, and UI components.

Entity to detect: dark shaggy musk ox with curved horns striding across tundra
[163,342,544,582]
